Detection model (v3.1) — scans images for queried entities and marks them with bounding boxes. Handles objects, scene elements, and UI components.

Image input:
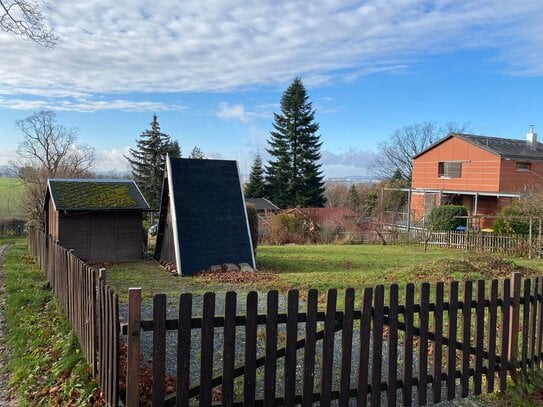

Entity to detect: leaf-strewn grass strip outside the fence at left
[0,239,98,406]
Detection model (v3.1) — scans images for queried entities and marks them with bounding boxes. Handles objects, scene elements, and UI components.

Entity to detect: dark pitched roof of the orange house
[413,133,543,161]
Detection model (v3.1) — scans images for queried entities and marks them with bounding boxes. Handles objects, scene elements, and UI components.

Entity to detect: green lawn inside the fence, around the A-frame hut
[101,245,543,301]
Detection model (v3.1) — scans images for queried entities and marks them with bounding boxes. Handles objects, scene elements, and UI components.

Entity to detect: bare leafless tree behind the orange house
[372,122,469,180]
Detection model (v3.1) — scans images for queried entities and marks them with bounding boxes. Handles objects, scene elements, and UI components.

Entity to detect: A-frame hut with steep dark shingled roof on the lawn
[155,158,255,275]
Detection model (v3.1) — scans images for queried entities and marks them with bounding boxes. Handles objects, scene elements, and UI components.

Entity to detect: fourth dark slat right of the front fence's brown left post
[222,291,237,406]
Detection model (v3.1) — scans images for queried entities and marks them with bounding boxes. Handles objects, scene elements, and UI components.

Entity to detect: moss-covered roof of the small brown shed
[47,178,149,210]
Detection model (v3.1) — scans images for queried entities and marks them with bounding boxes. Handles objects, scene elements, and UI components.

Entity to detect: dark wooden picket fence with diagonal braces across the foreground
[122,273,543,406]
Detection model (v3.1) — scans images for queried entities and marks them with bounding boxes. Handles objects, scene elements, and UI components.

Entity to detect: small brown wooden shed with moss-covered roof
[44,179,149,262]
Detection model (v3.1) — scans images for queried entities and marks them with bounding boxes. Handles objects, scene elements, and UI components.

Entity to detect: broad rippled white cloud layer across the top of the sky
[0,0,543,99]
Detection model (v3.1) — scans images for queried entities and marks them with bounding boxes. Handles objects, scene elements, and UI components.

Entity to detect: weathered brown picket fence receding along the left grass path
[28,231,120,406]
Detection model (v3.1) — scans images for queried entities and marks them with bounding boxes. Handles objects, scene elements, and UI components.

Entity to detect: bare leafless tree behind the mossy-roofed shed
[12,111,95,226]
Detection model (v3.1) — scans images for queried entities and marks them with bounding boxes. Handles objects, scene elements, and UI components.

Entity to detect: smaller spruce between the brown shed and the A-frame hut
[125,115,181,209]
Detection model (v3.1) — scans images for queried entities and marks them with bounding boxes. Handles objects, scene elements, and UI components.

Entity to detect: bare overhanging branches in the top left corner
[0,0,58,48]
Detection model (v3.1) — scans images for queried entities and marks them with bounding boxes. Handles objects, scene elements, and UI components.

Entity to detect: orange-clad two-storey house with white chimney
[410,129,543,228]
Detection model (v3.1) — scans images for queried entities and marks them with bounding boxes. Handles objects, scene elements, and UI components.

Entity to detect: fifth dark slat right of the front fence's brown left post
[243,291,258,406]
